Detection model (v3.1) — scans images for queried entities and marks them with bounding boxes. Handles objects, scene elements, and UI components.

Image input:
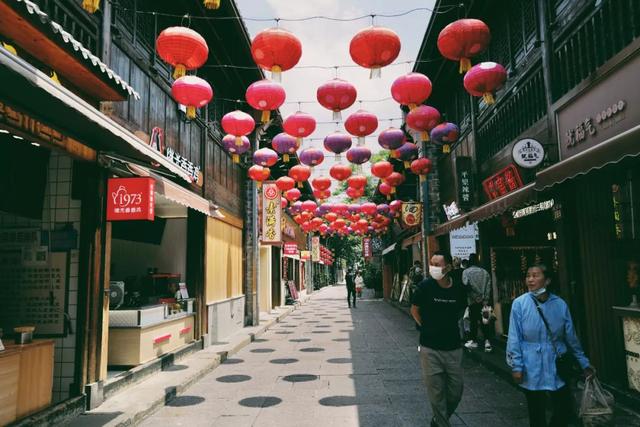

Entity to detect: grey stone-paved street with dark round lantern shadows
[143,287,528,427]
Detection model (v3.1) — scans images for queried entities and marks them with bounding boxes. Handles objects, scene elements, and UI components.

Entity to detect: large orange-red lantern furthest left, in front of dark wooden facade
[156,27,209,79]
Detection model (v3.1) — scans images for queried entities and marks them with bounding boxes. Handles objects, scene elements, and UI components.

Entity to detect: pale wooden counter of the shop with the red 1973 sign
[108,312,195,366]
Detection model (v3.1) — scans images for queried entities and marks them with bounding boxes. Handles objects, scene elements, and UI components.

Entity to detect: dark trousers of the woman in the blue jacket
[524,385,573,427]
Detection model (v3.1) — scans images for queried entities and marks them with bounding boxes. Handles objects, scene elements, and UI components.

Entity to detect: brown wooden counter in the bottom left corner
[0,338,54,425]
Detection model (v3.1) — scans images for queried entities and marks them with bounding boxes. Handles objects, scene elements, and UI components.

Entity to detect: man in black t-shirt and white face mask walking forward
[411,252,466,427]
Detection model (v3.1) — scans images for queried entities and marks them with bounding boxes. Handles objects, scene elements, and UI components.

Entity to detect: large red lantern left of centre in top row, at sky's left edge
[251,28,302,82]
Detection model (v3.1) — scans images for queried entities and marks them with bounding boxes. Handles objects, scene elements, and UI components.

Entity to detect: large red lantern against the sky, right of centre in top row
[349,27,400,77]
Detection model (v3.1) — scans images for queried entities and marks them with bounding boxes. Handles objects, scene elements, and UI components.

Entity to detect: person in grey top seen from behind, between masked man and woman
[462,253,493,352]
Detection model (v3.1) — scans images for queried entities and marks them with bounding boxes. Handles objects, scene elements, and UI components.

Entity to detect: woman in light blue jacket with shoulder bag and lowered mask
[507,264,594,427]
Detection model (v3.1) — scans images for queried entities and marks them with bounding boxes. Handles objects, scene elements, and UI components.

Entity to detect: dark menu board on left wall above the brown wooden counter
[0,247,68,336]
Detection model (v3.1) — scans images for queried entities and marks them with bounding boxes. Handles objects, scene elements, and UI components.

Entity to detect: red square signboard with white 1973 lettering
[107,178,155,221]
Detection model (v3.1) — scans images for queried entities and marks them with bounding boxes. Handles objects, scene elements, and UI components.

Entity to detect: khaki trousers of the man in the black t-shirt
[420,346,464,427]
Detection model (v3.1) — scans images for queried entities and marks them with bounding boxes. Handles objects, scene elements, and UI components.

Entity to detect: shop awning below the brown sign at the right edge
[536,125,640,191]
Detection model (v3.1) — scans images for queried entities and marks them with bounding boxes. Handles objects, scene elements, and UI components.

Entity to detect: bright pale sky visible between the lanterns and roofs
[236,0,435,182]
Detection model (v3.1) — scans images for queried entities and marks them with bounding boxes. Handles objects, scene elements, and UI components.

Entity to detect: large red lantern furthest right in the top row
[438,19,491,74]
